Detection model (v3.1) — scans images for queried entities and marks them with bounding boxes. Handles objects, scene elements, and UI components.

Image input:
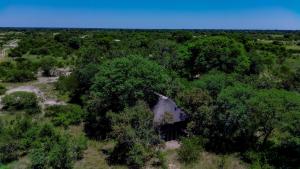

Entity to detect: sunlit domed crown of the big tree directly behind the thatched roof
[92,56,177,111]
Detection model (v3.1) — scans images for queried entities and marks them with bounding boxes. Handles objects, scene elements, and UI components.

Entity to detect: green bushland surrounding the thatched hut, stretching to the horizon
[0,29,300,169]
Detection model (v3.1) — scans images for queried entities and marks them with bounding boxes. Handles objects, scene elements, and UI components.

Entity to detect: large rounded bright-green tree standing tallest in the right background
[186,36,250,78]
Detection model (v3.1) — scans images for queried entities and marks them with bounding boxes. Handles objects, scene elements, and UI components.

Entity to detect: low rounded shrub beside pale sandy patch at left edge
[2,92,40,114]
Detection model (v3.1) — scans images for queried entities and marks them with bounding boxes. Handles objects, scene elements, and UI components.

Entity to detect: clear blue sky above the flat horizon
[0,0,300,30]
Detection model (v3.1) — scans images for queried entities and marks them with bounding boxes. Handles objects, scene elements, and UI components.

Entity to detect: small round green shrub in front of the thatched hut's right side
[178,137,203,163]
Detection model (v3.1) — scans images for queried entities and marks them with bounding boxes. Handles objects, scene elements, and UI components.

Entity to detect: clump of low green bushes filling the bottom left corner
[0,116,87,169]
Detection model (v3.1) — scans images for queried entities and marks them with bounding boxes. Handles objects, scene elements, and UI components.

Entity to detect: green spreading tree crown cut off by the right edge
[248,89,300,146]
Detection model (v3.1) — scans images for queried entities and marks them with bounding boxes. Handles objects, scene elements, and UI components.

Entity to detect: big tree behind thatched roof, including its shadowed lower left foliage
[85,56,180,139]
